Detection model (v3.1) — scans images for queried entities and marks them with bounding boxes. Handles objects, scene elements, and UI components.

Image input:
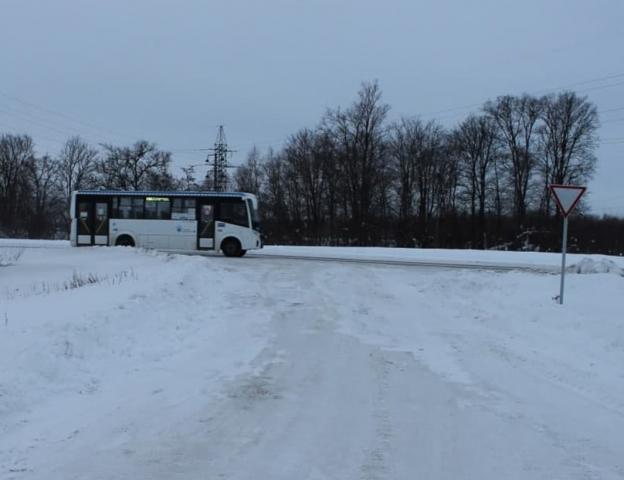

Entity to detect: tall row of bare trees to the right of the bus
[235,82,599,247]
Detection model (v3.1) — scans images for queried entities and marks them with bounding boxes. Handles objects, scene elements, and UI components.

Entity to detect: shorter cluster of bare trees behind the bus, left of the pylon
[0,135,178,237]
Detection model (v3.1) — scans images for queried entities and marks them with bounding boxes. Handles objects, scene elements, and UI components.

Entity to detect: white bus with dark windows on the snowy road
[70,190,262,257]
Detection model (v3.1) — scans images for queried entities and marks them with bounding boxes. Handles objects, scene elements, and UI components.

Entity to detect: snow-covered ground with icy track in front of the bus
[0,241,624,480]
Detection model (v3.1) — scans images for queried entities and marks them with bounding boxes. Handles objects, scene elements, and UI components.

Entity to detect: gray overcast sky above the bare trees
[0,0,624,214]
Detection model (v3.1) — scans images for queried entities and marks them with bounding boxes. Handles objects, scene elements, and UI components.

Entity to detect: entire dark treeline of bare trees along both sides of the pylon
[0,82,624,254]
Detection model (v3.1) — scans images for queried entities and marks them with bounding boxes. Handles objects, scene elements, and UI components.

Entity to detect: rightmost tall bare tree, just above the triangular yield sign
[539,92,598,214]
